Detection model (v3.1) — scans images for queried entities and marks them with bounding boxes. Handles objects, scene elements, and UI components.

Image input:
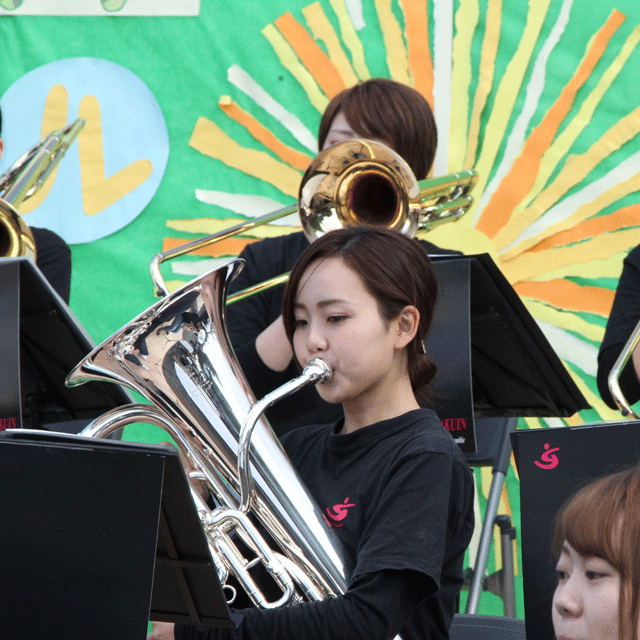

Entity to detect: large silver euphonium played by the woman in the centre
[67,259,350,608]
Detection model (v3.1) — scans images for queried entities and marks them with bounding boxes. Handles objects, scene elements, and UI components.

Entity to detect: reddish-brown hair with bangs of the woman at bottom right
[553,465,640,640]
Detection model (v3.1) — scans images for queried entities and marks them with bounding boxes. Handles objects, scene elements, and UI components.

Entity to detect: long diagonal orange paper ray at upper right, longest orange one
[476,10,625,238]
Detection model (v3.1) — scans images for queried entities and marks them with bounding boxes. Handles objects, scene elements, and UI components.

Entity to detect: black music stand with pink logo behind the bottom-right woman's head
[511,420,640,640]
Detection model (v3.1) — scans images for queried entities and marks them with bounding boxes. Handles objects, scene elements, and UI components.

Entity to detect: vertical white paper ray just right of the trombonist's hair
[433,0,453,176]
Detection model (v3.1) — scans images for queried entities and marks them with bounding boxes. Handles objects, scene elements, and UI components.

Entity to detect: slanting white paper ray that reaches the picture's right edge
[501,151,640,253]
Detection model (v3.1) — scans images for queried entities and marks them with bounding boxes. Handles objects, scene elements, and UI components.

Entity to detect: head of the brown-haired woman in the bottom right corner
[552,466,640,640]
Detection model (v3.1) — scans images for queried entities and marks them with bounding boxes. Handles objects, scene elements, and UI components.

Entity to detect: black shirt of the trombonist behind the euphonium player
[225,231,460,436]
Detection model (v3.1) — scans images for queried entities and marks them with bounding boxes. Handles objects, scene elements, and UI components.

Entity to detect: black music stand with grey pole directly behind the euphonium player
[426,254,589,614]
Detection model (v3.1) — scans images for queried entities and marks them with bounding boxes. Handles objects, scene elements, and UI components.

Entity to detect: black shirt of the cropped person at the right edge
[598,246,640,409]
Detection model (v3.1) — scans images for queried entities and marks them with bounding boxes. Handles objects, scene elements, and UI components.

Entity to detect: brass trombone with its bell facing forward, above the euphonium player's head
[149,140,478,304]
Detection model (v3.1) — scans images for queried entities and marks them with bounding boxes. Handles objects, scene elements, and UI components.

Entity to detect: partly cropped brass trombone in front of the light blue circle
[0,118,85,261]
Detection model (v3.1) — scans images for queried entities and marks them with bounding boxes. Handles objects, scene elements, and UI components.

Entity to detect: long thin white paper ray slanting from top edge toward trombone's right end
[474,0,573,224]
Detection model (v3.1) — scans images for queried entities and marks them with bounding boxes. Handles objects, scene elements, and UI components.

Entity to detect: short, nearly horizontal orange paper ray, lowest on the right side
[513,280,615,318]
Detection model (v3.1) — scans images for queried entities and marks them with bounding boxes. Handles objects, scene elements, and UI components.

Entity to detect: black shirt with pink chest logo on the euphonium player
[176,409,473,640]
